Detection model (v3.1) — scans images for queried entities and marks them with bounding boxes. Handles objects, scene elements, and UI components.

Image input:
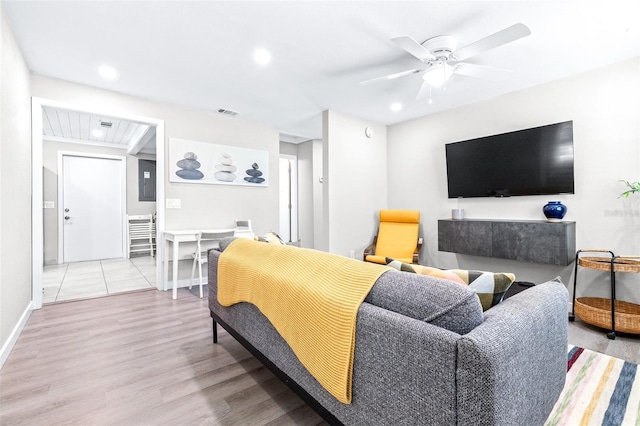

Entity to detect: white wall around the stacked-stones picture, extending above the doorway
[31,76,279,280]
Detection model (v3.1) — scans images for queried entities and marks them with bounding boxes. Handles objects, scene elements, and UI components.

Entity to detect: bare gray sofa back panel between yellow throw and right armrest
[338,302,460,425]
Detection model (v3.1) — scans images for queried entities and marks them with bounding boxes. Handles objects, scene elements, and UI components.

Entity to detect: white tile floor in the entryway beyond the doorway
[42,256,156,303]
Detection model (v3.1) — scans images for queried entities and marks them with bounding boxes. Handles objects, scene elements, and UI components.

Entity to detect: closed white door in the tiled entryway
[59,155,125,263]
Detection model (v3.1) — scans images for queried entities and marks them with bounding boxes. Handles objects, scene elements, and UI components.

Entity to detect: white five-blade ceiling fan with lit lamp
[361,23,531,99]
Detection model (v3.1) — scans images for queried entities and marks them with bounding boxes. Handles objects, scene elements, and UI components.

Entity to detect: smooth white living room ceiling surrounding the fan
[2,0,640,142]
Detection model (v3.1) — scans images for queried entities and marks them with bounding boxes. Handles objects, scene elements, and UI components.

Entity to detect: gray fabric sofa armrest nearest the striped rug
[457,279,569,426]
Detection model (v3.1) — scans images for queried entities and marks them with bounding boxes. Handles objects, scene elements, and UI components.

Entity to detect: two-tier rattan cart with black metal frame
[569,250,640,339]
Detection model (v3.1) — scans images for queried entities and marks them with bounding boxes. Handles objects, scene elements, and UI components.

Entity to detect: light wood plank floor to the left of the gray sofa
[0,289,325,426]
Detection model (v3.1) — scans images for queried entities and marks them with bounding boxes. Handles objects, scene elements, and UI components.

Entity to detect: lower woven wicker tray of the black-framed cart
[575,297,640,334]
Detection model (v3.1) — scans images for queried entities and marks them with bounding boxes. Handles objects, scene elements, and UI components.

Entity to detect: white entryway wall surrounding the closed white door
[42,141,156,265]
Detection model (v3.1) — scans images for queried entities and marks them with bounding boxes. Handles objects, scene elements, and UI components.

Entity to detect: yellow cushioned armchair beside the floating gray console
[364,210,422,265]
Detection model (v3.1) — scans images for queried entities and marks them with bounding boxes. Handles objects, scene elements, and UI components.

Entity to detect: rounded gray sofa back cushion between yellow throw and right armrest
[365,271,484,334]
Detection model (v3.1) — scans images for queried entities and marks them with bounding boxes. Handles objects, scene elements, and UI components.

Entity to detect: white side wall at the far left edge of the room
[0,3,31,366]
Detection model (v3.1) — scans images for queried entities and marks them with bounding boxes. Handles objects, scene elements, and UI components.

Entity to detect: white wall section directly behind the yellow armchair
[316,111,392,259]
